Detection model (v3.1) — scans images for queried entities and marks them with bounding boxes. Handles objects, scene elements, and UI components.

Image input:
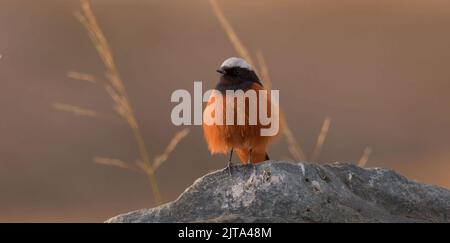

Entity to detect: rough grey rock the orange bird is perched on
[107,161,450,223]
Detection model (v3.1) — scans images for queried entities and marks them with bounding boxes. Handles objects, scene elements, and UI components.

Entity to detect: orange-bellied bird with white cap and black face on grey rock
[203,57,276,175]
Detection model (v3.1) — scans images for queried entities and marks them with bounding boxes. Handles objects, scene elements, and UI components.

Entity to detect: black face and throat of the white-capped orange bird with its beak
[216,67,262,92]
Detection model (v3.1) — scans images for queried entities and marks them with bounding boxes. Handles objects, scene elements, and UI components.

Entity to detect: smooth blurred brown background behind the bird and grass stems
[0,0,450,222]
